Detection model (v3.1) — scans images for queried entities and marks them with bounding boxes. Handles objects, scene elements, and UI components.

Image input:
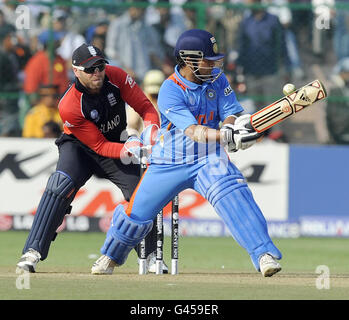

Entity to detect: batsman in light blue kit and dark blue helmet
[91,29,282,277]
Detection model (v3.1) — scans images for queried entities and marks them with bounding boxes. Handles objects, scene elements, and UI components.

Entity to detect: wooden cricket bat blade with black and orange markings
[251,80,327,132]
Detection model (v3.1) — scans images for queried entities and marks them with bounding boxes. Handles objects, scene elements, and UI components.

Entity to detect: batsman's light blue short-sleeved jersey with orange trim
[151,66,243,164]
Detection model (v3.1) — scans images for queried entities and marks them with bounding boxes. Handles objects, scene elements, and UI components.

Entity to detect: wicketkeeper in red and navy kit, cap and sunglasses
[17,44,167,272]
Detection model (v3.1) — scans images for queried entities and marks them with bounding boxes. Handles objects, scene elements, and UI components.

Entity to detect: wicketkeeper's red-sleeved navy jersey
[58,65,159,158]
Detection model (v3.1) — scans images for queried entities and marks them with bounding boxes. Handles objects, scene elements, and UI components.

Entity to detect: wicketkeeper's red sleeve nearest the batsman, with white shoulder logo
[106,66,160,127]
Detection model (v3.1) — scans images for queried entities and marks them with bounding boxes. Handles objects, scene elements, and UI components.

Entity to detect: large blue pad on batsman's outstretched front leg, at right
[194,162,282,271]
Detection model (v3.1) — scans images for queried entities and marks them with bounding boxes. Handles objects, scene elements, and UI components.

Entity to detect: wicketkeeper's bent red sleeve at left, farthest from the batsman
[59,86,124,158]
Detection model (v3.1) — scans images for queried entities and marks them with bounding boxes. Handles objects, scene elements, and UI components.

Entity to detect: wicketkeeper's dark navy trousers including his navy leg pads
[23,134,156,260]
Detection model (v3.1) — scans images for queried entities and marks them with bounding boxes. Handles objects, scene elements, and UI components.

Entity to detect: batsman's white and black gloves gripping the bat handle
[220,114,263,152]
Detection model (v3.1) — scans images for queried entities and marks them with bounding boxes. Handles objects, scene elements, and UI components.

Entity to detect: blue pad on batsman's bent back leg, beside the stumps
[101,205,153,266]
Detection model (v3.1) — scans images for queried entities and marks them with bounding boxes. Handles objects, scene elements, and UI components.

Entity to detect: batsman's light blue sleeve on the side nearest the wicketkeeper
[158,80,197,130]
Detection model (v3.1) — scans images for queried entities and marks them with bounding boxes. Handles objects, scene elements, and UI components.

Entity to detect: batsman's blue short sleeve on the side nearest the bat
[217,74,244,121]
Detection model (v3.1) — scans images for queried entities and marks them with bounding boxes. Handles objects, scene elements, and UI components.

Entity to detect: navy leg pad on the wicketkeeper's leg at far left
[23,171,75,260]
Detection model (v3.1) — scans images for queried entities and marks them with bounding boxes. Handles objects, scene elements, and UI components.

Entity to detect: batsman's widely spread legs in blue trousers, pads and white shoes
[92,153,281,276]
